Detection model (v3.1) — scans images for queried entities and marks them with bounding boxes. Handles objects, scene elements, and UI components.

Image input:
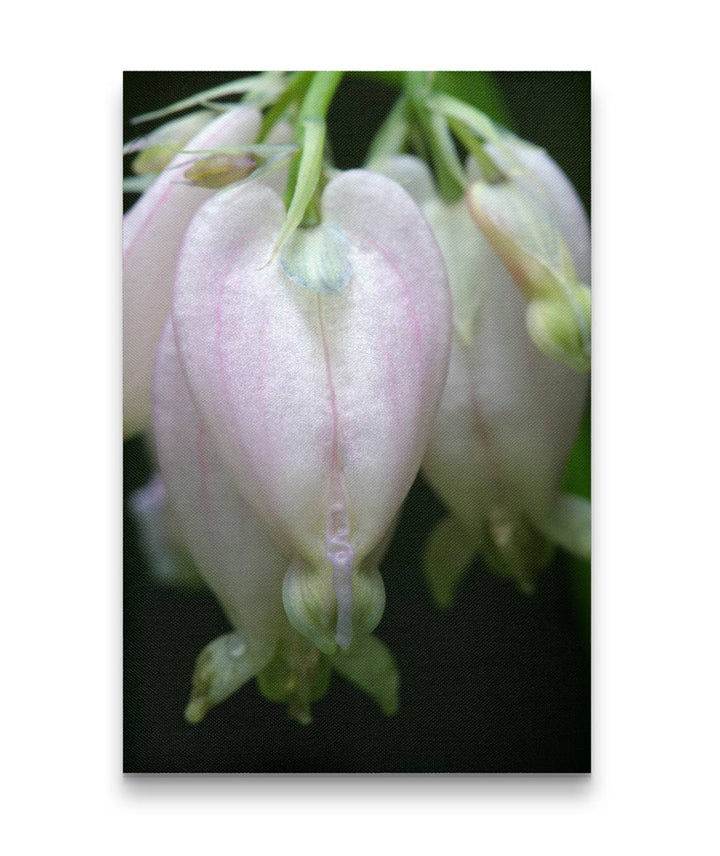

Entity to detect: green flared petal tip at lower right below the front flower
[330,636,400,716]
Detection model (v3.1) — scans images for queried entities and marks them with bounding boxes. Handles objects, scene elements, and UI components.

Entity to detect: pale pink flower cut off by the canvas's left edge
[123,107,260,436]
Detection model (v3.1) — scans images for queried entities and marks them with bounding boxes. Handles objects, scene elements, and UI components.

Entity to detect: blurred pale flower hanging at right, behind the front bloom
[382,137,590,605]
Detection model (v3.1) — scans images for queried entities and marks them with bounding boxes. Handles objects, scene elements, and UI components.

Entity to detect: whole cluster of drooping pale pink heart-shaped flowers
[123,77,590,722]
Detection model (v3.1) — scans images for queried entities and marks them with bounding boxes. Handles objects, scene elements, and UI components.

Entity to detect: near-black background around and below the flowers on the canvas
[124,72,590,773]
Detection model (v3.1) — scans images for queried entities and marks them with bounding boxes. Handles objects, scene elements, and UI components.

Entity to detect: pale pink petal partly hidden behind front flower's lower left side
[153,322,287,660]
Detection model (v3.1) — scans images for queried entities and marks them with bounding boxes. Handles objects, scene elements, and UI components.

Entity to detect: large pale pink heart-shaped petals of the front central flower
[173,171,450,644]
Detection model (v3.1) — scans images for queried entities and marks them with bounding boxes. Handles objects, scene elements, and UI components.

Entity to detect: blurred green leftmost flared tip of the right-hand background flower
[423,515,478,609]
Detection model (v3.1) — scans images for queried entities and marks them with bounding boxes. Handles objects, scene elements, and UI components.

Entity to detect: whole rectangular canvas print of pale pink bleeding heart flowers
[122,71,591,773]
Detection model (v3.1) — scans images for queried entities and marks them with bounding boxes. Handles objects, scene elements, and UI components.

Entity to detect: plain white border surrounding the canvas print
[2,2,718,854]
